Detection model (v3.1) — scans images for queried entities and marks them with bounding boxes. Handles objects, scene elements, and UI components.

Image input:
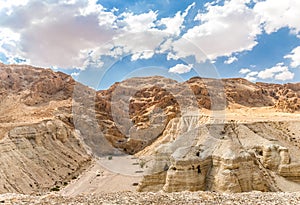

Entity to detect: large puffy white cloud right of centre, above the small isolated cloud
[173,0,261,62]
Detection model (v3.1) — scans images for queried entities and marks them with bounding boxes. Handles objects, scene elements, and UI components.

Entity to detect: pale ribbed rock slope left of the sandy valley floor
[0,120,90,194]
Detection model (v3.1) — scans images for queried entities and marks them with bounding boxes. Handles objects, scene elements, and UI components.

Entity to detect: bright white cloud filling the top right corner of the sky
[254,0,300,34]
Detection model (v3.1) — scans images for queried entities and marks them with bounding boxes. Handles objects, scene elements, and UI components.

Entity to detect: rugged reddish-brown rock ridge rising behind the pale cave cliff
[90,77,298,157]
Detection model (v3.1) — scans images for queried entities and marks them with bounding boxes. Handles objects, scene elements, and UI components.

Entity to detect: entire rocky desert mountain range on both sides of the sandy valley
[0,64,300,194]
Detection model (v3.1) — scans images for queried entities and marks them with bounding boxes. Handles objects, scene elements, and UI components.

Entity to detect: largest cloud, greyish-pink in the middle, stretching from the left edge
[0,0,200,69]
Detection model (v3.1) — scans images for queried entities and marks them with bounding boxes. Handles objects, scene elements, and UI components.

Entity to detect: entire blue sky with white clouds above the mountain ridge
[0,0,300,89]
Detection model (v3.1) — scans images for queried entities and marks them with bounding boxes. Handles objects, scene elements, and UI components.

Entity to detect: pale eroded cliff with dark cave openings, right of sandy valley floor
[138,118,300,192]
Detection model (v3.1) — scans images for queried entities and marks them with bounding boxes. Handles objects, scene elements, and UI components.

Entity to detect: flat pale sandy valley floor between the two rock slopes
[60,156,143,196]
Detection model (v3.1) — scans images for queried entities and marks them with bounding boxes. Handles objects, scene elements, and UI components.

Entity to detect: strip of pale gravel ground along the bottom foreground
[0,192,300,205]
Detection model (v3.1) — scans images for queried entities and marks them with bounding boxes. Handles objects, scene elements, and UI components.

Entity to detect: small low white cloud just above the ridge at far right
[257,63,294,81]
